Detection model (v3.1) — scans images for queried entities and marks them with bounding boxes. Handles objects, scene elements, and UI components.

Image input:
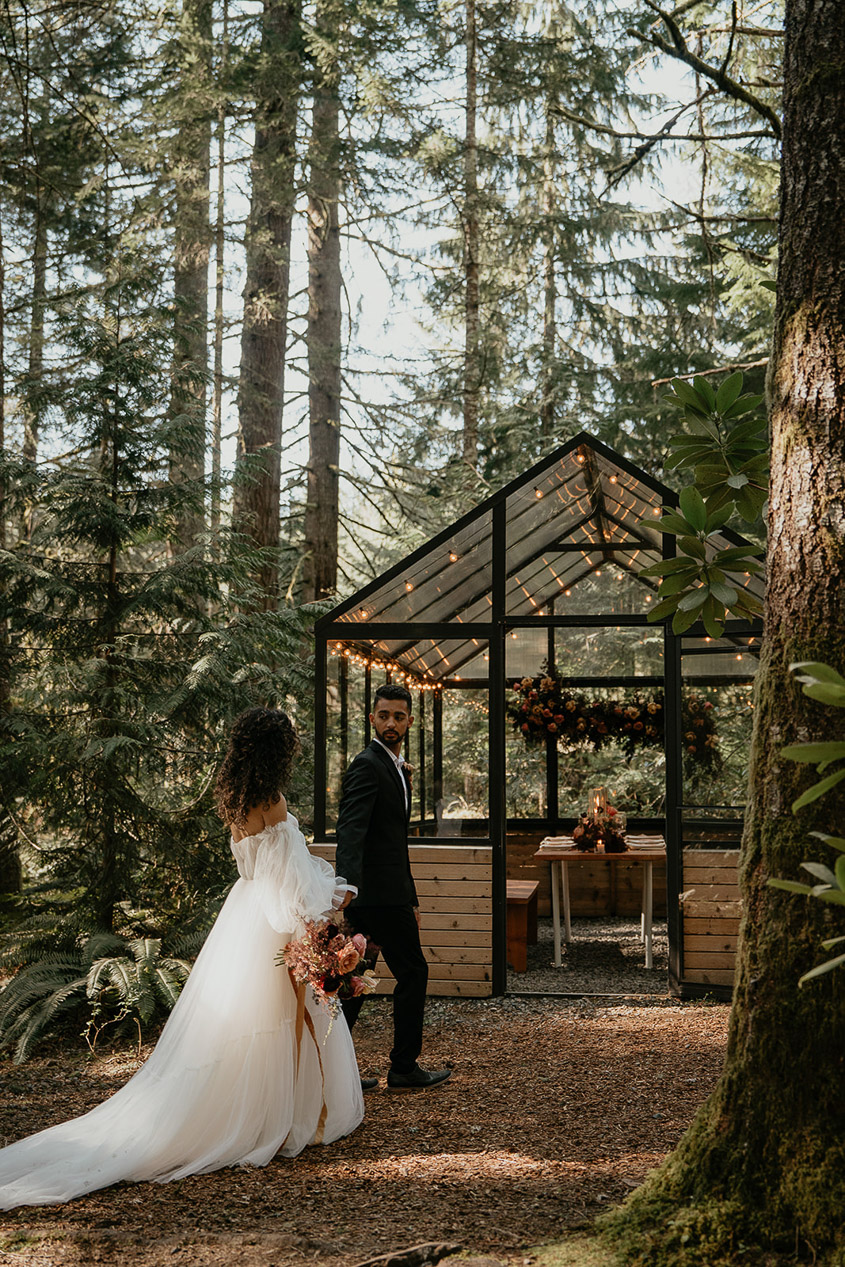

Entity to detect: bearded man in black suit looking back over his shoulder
[336,684,451,1090]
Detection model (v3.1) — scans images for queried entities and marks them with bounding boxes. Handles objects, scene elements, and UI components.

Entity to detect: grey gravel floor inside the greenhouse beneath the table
[508,916,669,995]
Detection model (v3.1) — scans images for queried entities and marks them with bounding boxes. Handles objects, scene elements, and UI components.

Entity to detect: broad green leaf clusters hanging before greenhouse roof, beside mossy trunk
[640,372,768,637]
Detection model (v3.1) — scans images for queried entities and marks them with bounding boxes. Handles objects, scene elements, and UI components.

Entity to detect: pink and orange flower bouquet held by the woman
[276,920,378,1012]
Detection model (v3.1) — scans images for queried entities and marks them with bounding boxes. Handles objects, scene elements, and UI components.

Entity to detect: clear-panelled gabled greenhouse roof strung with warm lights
[318,432,763,680]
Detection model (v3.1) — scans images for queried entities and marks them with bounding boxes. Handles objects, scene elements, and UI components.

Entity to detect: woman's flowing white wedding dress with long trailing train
[0,816,364,1210]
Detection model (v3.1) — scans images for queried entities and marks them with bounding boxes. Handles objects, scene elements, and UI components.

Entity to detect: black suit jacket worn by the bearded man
[334,740,417,906]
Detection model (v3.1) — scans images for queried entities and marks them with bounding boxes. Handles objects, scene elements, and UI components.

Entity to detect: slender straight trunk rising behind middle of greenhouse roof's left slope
[462,0,481,469]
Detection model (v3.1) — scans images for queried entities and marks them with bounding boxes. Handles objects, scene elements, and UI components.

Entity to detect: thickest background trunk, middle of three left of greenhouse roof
[233,0,302,609]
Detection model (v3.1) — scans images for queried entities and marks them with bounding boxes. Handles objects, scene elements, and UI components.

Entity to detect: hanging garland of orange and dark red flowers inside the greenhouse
[508,674,720,765]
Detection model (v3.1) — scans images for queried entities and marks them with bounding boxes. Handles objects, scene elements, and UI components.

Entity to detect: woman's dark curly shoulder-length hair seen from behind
[214,708,299,827]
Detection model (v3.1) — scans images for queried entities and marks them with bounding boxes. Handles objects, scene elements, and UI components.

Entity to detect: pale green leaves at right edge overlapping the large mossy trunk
[768,660,845,986]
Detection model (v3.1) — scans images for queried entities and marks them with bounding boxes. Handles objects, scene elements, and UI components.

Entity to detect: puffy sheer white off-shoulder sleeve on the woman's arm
[252,817,347,935]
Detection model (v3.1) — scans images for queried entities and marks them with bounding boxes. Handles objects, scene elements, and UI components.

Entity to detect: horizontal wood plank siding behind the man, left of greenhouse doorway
[310,843,493,997]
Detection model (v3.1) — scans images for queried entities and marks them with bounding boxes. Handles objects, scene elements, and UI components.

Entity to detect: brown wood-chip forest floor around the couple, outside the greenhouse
[0,997,728,1267]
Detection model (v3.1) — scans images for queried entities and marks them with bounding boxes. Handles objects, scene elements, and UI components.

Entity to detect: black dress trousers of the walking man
[343,903,428,1073]
